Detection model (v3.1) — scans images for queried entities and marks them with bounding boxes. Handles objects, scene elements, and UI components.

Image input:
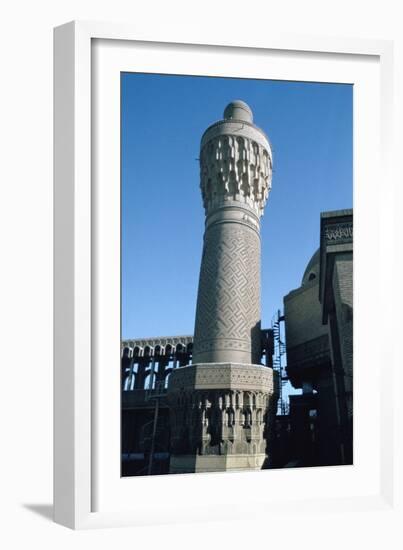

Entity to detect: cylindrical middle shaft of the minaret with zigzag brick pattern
[193,223,260,363]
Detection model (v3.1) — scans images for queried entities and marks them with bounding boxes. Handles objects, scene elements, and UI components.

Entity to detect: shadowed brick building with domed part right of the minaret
[284,210,353,466]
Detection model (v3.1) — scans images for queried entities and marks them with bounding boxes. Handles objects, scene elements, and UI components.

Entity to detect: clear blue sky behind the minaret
[121,73,353,338]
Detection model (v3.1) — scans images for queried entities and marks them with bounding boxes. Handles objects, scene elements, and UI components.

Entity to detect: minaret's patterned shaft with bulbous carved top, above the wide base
[193,101,272,364]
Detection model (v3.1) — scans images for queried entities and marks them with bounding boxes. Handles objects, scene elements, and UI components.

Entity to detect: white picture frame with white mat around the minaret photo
[54,22,395,529]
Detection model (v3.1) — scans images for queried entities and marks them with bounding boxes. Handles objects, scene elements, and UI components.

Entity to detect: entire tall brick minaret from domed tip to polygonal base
[168,101,276,473]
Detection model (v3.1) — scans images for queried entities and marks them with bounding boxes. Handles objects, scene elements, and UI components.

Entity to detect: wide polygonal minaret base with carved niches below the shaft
[167,363,278,473]
